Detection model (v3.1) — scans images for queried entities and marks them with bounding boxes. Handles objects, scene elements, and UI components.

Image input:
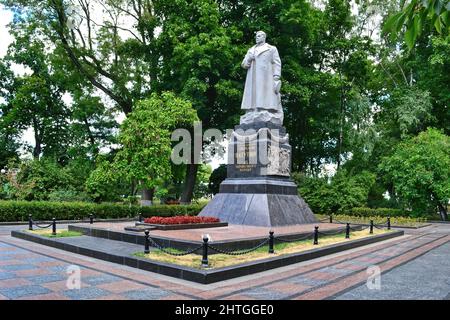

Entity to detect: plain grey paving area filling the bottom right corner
[336,243,450,300]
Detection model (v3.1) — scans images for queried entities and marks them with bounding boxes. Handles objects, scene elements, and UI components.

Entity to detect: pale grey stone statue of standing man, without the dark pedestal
[241,31,283,125]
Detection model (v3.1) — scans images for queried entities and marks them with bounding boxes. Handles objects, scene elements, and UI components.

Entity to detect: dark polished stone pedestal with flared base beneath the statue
[200,122,318,227]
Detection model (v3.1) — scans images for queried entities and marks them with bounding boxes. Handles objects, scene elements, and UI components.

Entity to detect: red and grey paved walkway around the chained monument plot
[0,224,450,300]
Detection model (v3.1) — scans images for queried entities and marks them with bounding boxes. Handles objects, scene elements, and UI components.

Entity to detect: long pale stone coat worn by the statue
[241,43,281,110]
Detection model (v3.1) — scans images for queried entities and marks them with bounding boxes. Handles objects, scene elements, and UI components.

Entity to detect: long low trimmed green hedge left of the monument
[0,201,205,222]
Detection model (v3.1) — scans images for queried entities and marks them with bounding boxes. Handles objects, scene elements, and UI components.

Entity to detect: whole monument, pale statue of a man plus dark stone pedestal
[200,31,317,227]
